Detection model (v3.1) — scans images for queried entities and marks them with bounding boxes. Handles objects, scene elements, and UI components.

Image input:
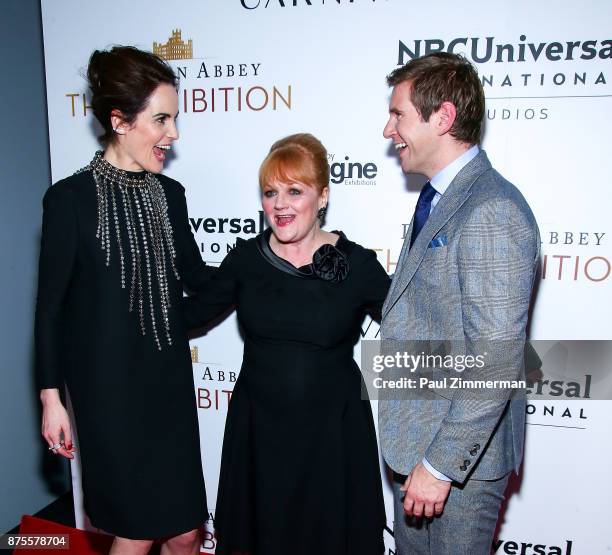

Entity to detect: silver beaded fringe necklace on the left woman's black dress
[76,151,180,351]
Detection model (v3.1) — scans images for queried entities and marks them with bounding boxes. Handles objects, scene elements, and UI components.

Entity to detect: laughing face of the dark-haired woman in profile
[108,83,179,173]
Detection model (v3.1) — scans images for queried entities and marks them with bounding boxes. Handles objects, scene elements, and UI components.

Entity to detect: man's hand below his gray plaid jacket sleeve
[400,463,451,518]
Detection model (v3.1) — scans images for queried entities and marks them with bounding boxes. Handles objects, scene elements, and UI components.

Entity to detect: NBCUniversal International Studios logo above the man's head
[396,34,612,121]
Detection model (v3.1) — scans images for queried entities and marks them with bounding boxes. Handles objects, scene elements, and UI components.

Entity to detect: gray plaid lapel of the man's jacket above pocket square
[382,150,491,319]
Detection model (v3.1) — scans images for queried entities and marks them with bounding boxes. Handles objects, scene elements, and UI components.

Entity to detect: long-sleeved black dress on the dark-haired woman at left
[36,171,211,539]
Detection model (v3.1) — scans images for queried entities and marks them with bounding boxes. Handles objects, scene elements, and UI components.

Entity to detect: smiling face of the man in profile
[383,81,439,178]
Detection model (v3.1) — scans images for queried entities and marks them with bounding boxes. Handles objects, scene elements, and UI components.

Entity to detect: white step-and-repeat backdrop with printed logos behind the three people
[40,0,612,555]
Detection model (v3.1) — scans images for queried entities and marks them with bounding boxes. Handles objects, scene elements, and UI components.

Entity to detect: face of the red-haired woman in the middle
[262,180,329,243]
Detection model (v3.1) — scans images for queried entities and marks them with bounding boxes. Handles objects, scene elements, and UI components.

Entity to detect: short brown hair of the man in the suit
[387,52,485,145]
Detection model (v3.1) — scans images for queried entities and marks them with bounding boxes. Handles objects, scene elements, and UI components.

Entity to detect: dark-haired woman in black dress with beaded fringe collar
[36,47,209,554]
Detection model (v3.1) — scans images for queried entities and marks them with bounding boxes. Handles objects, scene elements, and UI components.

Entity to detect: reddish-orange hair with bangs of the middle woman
[259,133,329,194]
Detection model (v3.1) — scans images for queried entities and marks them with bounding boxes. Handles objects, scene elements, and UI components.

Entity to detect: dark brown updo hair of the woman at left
[87,46,178,144]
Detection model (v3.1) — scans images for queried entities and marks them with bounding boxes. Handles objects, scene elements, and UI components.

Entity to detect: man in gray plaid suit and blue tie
[379,53,540,555]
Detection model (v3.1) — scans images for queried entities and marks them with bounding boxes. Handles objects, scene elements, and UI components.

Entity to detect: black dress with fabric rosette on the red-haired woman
[186,230,389,555]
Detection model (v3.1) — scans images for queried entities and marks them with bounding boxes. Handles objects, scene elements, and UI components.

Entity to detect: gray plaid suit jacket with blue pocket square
[379,151,540,483]
